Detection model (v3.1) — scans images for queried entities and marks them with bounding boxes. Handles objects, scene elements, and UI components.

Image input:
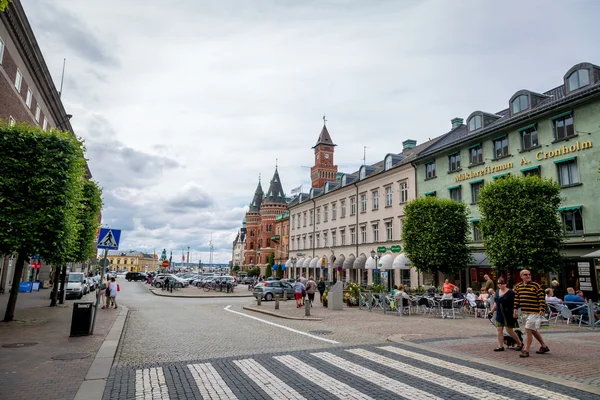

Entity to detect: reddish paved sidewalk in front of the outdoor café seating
[244,301,600,394]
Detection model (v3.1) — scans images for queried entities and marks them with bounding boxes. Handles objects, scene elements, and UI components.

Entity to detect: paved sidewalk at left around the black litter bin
[0,289,121,400]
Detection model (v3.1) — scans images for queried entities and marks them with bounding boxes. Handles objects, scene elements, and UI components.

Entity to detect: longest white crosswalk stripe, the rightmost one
[379,346,572,400]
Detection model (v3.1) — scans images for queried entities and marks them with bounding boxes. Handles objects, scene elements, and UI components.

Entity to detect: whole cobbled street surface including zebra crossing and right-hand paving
[104,283,600,399]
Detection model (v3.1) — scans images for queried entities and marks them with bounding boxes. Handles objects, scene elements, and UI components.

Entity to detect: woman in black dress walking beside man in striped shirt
[490,278,523,351]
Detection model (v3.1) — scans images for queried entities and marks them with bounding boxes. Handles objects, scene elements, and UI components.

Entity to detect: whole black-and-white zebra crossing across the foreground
[125,345,594,400]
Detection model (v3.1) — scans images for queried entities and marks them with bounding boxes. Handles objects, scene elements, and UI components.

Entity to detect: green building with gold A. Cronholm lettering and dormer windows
[413,63,600,298]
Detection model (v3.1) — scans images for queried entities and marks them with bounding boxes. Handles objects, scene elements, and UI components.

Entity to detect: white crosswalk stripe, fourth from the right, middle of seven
[273,356,372,400]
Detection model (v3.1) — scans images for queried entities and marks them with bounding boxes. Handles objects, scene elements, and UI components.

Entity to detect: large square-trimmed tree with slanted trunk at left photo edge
[0,124,85,321]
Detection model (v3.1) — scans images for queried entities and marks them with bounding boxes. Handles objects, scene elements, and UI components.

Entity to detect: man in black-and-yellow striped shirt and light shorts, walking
[514,269,550,358]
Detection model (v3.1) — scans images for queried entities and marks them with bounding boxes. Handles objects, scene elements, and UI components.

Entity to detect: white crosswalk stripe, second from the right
[346,349,511,400]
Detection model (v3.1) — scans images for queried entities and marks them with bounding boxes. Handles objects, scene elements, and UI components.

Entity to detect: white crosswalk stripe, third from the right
[312,352,441,399]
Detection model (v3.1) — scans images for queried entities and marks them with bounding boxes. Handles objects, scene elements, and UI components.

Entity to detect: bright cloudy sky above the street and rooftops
[22,0,600,263]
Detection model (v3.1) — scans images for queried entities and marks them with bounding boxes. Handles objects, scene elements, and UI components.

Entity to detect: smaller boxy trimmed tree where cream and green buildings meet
[402,197,471,285]
